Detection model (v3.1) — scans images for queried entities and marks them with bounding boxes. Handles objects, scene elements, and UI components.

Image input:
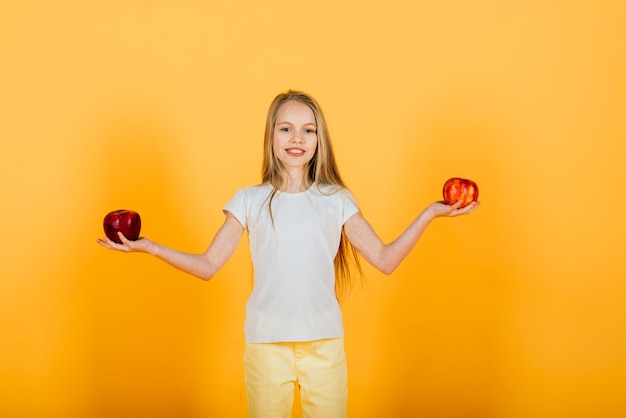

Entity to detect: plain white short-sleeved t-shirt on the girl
[224,185,359,343]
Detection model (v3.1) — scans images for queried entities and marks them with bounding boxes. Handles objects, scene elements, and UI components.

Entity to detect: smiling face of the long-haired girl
[273,100,317,172]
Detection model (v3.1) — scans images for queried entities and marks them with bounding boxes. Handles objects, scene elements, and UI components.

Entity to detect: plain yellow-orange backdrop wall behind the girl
[0,0,626,418]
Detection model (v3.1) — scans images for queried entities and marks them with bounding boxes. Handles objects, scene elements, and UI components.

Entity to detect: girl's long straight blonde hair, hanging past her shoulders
[262,90,363,299]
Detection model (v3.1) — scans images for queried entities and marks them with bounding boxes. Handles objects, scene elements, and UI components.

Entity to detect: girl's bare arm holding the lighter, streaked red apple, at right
[344,202,478,274]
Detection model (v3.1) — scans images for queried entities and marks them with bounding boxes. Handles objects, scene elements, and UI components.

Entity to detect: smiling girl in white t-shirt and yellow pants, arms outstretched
[98,91,478,418]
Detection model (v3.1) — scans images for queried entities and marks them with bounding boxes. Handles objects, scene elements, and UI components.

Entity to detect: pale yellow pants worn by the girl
[244,338,348,418]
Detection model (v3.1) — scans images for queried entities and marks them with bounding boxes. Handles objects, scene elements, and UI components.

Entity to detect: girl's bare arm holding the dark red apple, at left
[97,212,244,280]
